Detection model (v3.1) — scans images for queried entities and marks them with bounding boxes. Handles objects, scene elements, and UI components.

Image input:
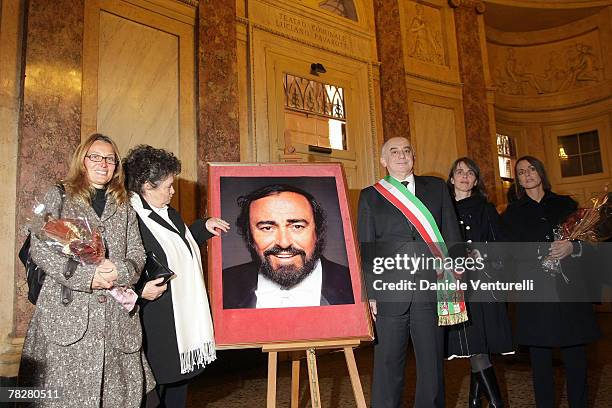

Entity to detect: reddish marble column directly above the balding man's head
[374,0,410,140]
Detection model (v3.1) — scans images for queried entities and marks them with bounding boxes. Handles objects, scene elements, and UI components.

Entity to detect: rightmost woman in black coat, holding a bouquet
[502,156,600,408]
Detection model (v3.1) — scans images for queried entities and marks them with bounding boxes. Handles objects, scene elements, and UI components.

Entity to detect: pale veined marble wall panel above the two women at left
[97,11,183,157]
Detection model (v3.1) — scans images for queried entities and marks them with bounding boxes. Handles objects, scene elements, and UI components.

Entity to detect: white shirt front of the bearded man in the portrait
[255,259,323,309]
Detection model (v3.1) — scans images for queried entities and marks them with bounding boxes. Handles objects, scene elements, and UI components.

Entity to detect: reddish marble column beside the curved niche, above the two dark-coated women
[449,0,497,196]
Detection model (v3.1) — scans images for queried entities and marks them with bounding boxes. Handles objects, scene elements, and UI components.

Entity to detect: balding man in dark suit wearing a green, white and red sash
[358,138,460,408]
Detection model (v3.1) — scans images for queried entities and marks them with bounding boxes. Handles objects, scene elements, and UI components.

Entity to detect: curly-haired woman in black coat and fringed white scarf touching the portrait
[125,145,229,408]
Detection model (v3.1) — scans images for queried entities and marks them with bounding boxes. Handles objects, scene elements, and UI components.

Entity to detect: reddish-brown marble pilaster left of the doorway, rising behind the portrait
[197,0,240,212]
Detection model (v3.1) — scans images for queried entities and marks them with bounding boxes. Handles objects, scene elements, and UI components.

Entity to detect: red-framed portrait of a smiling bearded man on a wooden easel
[208,163,373,348]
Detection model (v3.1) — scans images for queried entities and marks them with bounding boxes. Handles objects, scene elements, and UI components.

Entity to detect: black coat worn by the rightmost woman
[502,191,600,347]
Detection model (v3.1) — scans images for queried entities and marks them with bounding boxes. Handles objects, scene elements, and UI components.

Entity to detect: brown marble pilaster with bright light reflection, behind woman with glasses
[15,0,84,336]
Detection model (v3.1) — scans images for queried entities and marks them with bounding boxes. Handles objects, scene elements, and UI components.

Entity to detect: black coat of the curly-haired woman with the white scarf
[136,199,213,384]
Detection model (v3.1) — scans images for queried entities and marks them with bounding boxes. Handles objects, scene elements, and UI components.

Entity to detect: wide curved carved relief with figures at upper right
[487,12,612,111]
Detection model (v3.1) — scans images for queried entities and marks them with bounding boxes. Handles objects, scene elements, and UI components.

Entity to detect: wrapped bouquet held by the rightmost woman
[542,187,612,283]
